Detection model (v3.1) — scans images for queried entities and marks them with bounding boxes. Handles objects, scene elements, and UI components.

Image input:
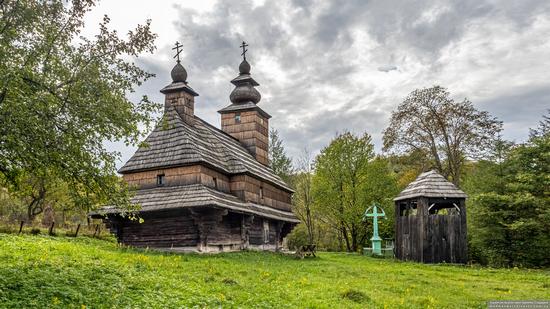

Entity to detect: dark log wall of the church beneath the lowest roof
[105,207,292,252]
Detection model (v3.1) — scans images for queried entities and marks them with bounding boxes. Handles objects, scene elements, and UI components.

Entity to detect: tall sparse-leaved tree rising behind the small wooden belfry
[383,86,502,185]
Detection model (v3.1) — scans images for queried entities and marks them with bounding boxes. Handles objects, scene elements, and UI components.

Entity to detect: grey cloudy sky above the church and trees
[85,0,550,168]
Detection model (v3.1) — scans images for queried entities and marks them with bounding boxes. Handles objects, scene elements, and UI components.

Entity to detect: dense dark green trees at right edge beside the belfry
[467,112,550,266]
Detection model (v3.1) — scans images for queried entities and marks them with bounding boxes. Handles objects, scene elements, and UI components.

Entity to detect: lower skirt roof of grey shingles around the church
[92,184,300,223]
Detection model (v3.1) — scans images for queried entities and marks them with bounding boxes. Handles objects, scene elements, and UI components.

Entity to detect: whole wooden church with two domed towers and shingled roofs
[94,42,299,252]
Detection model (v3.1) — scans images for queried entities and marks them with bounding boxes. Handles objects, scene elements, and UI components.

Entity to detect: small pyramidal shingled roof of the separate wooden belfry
[394,171,468,201]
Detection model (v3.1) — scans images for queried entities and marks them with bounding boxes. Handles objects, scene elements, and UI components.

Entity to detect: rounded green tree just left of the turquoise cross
[313,132,397,252]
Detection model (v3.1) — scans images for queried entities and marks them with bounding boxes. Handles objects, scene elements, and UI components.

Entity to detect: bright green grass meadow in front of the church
[0,234,550,308]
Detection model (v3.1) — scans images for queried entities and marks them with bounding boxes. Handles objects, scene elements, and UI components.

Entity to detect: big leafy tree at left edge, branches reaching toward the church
[0,0,158,212]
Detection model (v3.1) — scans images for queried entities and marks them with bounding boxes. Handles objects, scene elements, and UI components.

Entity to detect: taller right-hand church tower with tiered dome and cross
[218,42,271,165]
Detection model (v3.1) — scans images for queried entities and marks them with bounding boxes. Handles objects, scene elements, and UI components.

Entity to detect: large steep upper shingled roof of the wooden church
[119,107,293,192]
